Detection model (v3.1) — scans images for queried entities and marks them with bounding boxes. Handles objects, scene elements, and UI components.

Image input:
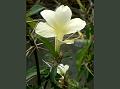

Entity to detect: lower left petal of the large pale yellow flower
[35,22,55,38]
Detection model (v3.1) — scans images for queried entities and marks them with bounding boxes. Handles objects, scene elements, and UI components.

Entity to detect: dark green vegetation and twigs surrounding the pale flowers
[26,0,94,89]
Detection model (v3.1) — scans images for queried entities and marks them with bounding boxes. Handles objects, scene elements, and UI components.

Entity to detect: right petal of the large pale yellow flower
[67,18,86,34]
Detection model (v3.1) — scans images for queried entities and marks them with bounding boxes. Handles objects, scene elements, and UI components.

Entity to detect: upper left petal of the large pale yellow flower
[40,10,56,27]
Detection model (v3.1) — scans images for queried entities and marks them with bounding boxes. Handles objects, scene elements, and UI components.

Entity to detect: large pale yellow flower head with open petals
[35,5,86,41]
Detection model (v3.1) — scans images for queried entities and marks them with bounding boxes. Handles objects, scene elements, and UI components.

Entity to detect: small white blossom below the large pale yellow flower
[57,64,69,76]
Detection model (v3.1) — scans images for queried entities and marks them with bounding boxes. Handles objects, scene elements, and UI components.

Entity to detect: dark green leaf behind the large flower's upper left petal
[26,4,45,17]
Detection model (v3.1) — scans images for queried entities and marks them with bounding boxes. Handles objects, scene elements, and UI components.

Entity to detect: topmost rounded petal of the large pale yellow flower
[55,5,72,24]
